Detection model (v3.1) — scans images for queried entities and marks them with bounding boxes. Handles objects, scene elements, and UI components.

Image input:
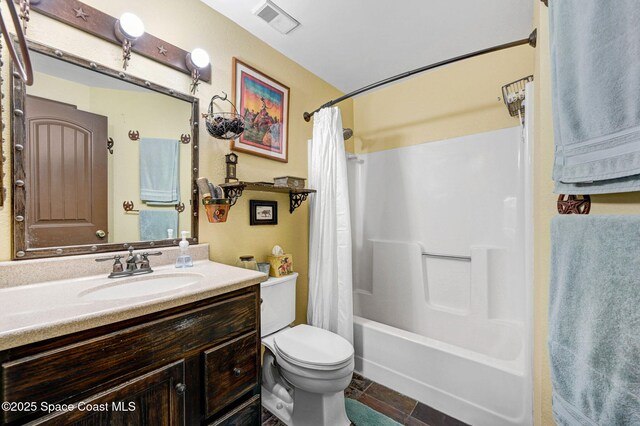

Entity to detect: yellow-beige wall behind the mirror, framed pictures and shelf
[0,0,353,322]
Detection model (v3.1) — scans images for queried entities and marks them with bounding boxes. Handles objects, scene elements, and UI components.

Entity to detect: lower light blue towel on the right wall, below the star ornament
[548,215,640,426]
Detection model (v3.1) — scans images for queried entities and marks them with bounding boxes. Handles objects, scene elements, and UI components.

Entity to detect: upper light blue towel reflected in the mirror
[139,138,180,205]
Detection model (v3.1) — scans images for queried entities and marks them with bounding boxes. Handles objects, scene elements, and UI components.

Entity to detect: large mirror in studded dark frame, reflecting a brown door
[11,42,199,259]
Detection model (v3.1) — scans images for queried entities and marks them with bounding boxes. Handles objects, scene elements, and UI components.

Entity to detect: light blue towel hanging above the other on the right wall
[549,0,640,194]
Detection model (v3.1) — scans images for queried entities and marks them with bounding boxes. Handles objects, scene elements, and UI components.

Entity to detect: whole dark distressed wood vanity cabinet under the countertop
[0,285,261,426]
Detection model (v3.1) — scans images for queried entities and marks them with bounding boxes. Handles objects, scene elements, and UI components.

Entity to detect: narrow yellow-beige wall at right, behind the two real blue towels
[533,4,640,426]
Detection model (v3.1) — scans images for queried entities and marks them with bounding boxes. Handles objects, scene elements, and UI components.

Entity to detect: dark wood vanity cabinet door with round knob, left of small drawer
[30,360,186,426]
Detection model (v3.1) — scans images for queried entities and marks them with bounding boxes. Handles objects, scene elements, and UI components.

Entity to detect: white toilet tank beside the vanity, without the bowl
[260,272,298,337]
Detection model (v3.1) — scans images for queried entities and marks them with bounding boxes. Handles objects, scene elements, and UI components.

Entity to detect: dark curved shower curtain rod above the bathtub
[302,29,538,122]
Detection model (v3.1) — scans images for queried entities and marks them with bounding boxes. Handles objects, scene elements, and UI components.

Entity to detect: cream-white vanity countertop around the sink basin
[0,260,268,350]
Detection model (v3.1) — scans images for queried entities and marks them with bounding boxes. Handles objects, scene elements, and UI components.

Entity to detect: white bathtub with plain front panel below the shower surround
[354,317,531,426]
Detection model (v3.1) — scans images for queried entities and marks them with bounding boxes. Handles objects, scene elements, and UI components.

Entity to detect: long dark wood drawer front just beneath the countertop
[1,293,258,422]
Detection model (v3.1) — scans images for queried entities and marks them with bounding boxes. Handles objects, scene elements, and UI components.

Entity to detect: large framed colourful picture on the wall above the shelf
[231,58,289,163]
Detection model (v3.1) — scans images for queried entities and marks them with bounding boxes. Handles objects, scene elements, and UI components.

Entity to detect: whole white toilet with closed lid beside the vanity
[260,273,354,426]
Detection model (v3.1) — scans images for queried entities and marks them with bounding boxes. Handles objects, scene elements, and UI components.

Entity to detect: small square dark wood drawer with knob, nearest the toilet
[204,332,259,417]
